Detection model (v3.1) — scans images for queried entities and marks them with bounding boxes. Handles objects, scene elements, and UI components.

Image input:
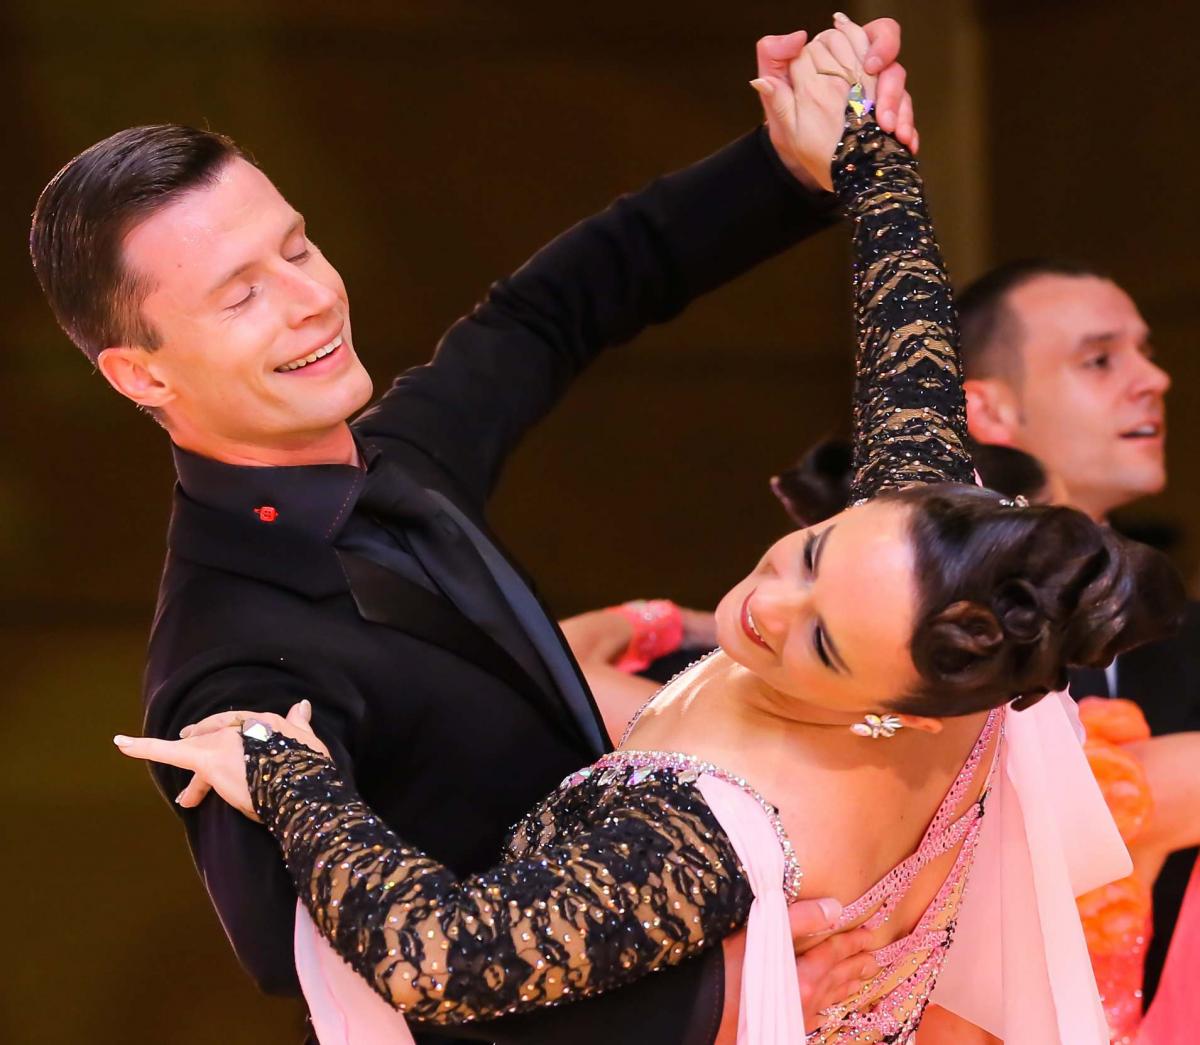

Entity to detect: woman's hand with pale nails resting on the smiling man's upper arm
[113,701,329,821]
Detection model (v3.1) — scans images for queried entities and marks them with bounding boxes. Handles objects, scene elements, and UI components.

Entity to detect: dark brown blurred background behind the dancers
[0,0,1200,1045]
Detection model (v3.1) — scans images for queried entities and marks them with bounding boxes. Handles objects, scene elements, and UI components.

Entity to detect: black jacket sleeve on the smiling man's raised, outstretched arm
[358,130,834,504]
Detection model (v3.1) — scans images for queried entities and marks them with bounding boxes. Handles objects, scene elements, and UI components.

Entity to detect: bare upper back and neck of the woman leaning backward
[622,654,998,964]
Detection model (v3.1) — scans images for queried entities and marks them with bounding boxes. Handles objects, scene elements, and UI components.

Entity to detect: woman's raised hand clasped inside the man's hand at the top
[751,14,878,191]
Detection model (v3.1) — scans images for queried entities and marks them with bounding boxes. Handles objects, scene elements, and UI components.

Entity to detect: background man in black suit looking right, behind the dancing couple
[959,260,1200,1003]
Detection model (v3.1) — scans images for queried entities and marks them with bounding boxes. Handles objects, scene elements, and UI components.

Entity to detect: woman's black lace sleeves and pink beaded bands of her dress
[245,100,997,1045]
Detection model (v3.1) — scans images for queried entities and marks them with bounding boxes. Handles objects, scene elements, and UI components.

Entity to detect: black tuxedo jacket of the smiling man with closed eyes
[145,131,832,1045]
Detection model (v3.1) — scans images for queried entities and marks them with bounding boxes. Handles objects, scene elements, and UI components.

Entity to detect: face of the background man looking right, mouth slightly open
[988,276,1170,518]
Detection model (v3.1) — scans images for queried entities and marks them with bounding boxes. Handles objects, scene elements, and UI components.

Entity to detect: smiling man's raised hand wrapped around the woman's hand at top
[756,18,920,188]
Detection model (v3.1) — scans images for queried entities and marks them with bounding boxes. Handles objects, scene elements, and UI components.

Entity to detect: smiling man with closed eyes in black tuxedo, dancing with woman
[31,19,913,1045]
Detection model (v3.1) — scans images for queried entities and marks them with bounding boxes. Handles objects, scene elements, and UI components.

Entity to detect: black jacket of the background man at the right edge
[1112,602,1200,1004]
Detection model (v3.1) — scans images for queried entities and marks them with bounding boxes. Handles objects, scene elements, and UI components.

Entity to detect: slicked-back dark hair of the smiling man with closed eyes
[29,124,247,362]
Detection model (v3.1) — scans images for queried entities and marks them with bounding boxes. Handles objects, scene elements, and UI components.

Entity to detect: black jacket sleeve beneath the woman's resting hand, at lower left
[145,649,366,995]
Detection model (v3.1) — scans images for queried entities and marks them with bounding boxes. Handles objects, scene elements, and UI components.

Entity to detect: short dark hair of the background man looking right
[956,258,1110,384]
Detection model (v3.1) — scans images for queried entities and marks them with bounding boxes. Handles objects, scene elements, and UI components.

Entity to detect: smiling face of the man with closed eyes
[118,160,371,463]
